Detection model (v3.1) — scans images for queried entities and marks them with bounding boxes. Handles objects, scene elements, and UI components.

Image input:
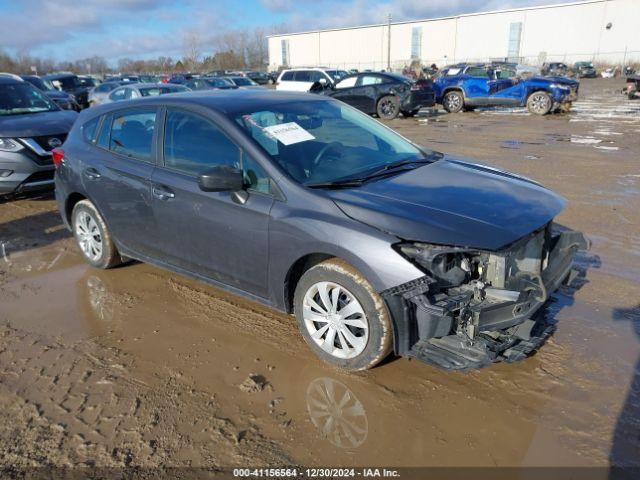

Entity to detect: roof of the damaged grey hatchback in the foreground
[91,89,336,115]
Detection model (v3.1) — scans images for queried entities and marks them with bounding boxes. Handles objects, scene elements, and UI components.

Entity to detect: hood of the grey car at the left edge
[0,110,78,137]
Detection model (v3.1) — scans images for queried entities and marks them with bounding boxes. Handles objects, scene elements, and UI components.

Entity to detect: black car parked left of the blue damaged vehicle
[312,73,435,120]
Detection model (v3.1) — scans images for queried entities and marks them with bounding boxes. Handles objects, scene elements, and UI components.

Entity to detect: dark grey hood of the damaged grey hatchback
[326,157,566,250]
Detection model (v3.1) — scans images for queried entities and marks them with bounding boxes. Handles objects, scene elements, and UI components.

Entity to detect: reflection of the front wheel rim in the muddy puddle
[307,377,369,450]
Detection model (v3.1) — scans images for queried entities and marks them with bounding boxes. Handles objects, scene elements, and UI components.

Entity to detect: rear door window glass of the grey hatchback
[109,109,156,163]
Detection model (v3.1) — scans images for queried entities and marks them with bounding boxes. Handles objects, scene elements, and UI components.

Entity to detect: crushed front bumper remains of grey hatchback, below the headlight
[381,226,589,370]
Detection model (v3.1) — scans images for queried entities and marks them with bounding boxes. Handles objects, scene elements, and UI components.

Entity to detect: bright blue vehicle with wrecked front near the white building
[433,63,580,115]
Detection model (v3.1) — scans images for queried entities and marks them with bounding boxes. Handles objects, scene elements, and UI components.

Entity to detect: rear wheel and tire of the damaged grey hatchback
[71,200,122,269]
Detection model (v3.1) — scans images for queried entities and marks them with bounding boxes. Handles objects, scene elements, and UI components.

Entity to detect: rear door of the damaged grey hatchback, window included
[82,107,157,256]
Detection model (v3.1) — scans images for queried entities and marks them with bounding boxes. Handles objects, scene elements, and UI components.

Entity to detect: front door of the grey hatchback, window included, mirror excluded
[151,108,274,297]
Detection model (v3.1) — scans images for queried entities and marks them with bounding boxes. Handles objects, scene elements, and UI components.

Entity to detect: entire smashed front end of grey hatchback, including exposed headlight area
[382,222,589,370]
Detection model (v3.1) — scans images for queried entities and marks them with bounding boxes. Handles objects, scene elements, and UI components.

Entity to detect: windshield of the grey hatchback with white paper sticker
[235,100,434,186]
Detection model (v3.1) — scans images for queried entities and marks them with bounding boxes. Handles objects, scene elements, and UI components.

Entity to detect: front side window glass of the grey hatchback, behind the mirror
[164,110,240,175]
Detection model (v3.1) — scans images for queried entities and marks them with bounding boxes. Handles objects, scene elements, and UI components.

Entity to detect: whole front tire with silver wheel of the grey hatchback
[294,259,393,371]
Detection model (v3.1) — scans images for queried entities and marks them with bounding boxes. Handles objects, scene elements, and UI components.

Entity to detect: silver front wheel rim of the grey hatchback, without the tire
[302,282,369,359]
